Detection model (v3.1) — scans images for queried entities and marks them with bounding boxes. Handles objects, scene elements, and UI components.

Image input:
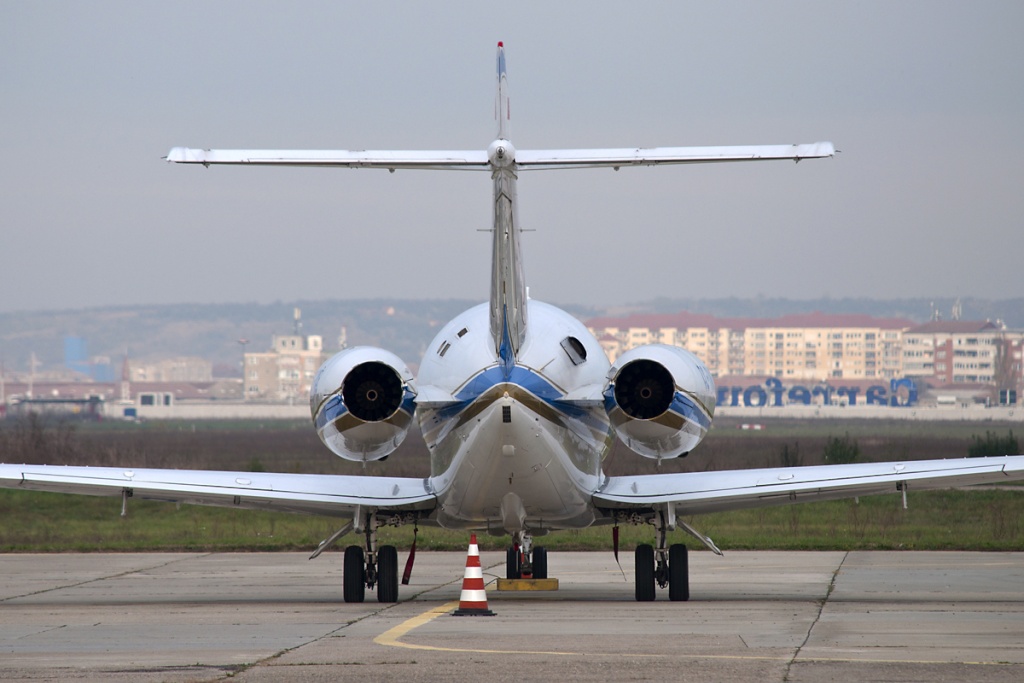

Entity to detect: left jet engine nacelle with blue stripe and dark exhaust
[309,346,416,462]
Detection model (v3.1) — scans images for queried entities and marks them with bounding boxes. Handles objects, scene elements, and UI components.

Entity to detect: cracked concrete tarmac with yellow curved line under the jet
[0,551,1024,683]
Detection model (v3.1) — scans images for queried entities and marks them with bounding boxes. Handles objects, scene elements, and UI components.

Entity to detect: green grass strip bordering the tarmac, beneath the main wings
[0,488,1024,552]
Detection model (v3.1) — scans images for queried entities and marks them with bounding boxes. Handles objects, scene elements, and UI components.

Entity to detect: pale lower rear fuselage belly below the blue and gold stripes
[432,396,603,533]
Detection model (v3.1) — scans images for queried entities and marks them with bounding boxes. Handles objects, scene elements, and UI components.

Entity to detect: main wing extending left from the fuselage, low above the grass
[0,465,436,517]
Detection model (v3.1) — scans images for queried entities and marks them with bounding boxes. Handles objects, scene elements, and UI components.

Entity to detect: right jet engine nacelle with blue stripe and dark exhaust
[604,344,717,460]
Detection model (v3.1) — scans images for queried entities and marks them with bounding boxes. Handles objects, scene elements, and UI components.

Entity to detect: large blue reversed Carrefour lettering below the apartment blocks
[717,377,918,408]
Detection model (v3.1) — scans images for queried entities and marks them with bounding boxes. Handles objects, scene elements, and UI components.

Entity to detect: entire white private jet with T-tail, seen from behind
[0,43,1024,602]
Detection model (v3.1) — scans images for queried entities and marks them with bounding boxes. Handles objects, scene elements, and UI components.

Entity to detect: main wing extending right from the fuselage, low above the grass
[594,456,1024,515]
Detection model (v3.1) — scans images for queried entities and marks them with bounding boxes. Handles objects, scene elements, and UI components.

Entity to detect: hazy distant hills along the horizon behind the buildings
[0,298,1024,375]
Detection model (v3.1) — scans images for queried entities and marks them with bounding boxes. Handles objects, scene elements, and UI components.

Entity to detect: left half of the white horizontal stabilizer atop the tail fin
[164,147,490,171]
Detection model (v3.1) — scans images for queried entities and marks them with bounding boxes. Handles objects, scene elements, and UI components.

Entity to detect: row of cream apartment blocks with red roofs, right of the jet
[588,312,1024,388]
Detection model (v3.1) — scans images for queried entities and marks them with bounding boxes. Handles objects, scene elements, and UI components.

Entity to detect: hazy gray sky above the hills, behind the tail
[0,0,1024,311]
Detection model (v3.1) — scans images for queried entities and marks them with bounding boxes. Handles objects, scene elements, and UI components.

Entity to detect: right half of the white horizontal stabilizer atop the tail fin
[515,142,836,170]
